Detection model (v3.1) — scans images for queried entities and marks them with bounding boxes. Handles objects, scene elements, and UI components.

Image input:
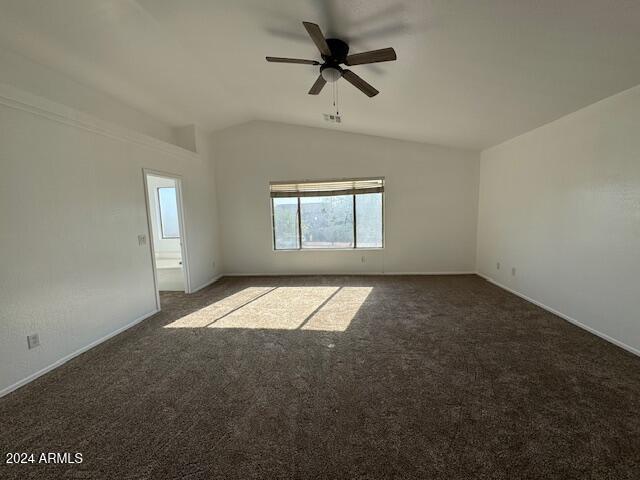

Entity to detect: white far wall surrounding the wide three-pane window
[212,122,479,273]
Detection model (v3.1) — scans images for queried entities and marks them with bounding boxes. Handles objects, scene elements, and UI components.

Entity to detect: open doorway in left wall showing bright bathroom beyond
[143,169,190,307]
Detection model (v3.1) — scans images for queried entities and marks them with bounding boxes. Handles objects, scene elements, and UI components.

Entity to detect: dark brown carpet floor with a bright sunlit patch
[0,275,640,480]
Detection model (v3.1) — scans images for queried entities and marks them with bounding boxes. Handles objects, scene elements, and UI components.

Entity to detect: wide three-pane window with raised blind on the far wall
[270,178,384,250]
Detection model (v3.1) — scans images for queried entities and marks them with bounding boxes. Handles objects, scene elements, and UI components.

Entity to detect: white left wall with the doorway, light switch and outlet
[0,85,219,394]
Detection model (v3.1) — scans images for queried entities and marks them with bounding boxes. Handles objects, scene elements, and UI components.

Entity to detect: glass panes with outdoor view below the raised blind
[272,193,382,250]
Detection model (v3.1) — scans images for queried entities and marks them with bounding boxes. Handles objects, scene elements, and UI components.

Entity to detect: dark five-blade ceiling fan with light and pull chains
[267,22,397,97]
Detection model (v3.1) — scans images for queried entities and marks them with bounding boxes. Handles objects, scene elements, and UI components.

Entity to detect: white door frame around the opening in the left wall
[142,168,191,310]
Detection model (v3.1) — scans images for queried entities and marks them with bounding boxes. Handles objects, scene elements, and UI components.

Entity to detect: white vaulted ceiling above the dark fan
[0,0,640,148]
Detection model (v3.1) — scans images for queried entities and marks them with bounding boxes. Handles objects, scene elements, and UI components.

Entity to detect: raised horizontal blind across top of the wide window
[269,178,384,198]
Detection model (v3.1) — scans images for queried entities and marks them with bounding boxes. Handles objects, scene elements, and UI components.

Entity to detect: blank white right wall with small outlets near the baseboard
[478,87,640,354]
